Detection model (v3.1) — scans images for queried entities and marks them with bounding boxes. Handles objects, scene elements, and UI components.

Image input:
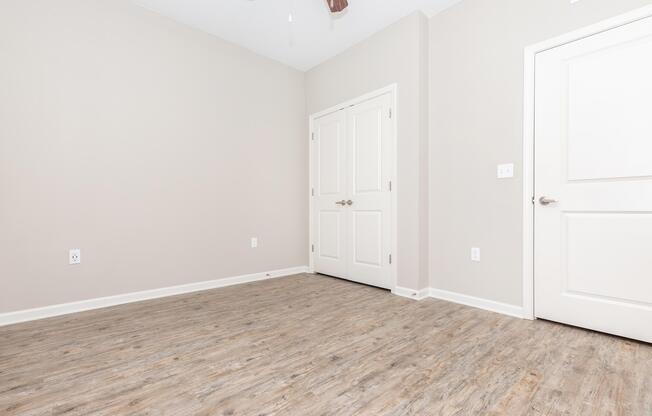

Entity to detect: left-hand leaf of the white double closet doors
[313,111,348,277]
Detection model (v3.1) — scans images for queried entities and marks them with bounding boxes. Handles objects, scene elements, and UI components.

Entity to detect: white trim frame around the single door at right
[523,6,652,319]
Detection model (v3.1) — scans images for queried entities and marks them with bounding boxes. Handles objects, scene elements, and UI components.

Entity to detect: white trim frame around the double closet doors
[308,84,400,291]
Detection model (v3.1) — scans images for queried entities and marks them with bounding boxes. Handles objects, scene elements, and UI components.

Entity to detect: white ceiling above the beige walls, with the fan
[134,0,460,71]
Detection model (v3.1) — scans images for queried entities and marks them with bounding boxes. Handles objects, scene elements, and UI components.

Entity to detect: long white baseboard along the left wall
[0,266,308,326]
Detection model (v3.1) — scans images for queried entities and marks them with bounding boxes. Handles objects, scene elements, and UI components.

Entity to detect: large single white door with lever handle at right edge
[535,18,652,342]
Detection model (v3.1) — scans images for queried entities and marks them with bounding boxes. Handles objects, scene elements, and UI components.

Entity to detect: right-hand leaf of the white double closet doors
[347,94,392,288]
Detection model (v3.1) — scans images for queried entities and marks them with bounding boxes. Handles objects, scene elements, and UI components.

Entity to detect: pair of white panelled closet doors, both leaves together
[312,93,394,288]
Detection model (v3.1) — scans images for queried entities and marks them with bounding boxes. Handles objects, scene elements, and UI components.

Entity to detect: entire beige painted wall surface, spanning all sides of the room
[0,0,650,313]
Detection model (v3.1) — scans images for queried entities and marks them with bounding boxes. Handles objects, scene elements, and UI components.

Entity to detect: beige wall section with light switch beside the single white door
[430,0,650,305]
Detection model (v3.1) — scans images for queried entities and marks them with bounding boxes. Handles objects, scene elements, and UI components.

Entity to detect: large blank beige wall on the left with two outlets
[0,0,308,313]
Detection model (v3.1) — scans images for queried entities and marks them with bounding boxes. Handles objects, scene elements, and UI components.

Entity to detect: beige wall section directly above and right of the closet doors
[306,13,428,289]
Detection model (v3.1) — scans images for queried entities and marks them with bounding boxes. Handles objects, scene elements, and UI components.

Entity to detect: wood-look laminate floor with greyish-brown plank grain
[0,275,652,416]
